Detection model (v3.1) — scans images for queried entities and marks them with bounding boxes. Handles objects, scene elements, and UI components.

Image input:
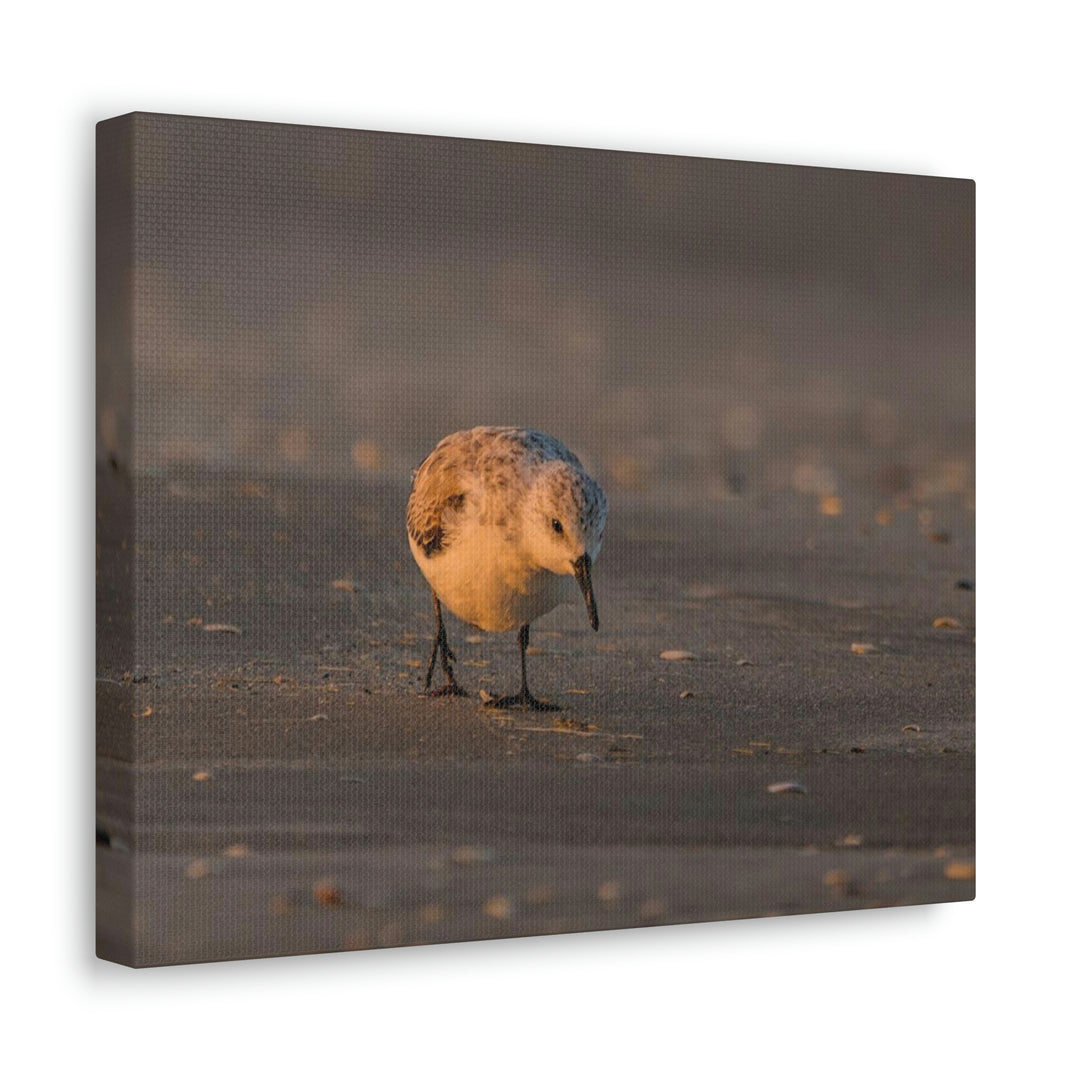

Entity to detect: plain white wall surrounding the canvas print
[0,0,1080,1077]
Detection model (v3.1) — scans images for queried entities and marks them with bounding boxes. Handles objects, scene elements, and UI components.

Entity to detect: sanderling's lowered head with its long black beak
[525,461,607,630]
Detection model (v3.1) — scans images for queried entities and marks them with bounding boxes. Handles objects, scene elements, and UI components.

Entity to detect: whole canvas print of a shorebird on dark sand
[96,112,975,967]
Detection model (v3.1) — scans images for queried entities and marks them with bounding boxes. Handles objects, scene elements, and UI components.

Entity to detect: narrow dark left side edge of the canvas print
[95,117,136,964]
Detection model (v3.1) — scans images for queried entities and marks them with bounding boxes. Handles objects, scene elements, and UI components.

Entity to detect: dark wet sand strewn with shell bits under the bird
[97,473,974,964]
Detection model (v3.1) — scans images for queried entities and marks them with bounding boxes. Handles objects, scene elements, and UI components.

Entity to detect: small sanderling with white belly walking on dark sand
[407,428,607,710]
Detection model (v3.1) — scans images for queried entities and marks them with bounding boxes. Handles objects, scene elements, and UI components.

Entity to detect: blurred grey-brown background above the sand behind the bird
[99,114,974,513]
